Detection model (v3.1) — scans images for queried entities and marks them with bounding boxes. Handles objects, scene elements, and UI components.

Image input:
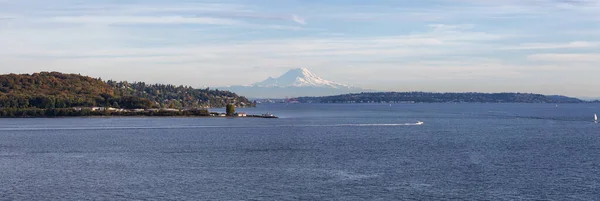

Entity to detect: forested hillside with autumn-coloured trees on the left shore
[0,72,253,109]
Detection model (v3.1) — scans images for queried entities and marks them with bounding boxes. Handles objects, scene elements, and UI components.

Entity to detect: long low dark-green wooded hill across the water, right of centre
[298,92,585,103]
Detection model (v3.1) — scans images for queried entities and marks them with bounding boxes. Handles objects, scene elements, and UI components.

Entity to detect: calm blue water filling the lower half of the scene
[0,104,600,200]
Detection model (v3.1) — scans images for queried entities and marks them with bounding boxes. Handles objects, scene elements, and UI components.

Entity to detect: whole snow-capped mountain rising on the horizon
[217,68,366,98]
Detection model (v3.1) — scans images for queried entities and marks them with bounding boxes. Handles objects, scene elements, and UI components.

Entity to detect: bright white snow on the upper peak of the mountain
[252,68,350,88]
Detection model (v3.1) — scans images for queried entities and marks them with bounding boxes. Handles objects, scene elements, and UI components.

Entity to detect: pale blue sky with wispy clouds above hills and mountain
[0,0,600,97]
